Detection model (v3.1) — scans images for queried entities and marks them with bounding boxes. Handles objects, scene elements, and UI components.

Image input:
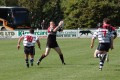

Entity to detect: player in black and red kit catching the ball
[37,21,65,65]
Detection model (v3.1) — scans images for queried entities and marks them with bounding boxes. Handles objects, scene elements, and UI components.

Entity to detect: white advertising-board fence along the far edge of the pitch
[0,29,120,39]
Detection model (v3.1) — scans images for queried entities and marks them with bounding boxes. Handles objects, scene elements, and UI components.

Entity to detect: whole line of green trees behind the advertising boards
[0,0,120,29]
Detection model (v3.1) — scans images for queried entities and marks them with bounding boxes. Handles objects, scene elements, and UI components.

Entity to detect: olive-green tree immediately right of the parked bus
[19,0,47,28]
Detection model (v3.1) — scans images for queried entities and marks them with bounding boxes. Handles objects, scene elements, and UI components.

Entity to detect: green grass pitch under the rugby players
[0,38,120,80]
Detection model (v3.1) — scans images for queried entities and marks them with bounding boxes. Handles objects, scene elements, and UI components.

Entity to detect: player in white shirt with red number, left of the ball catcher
[17,29,40,68]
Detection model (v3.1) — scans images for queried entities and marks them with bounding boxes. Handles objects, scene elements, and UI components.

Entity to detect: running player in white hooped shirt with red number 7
[90,27,114,70]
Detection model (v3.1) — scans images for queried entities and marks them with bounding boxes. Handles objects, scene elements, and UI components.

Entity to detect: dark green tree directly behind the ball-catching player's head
[43,0,63,26]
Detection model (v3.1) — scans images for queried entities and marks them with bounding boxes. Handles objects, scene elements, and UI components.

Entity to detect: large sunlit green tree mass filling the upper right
[62,0,120,29]
